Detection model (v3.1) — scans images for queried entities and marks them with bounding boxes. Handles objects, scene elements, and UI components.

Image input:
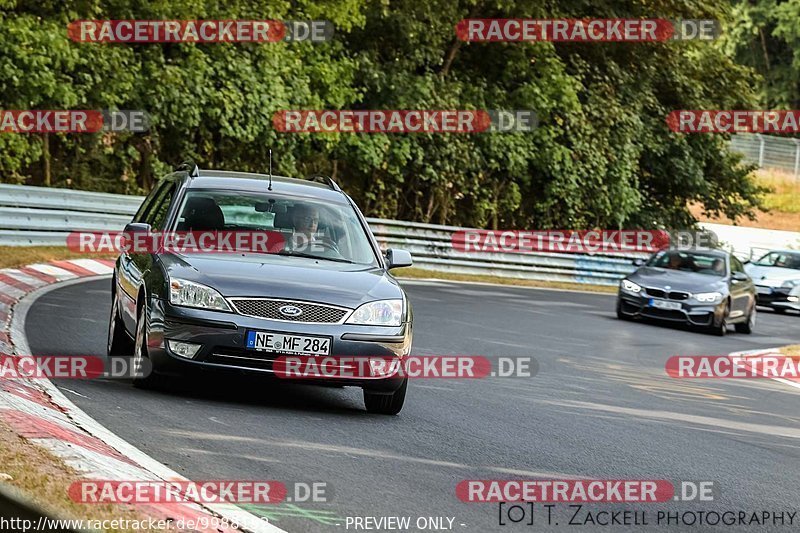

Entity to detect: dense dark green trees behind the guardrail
[0,0,768,228]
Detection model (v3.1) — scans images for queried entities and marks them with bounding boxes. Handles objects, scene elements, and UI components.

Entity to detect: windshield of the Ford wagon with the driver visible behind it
[174,190,378,266]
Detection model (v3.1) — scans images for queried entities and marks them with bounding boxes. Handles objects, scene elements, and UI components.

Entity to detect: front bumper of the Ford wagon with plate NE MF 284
[147,299,412,392]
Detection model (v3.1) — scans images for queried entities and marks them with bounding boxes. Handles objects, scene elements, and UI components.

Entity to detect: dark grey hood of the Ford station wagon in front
[161,254,403,309]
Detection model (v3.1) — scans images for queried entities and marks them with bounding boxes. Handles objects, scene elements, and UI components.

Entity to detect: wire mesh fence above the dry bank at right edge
[731,133,800,180]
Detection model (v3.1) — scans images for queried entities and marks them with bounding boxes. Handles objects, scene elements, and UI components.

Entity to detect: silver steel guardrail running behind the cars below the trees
[14,184,800,285]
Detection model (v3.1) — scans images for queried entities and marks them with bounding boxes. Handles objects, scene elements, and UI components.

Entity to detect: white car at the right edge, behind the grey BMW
[744,250,800,313]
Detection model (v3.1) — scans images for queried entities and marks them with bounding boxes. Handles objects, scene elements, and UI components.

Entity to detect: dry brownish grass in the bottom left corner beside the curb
[0,422,164,532]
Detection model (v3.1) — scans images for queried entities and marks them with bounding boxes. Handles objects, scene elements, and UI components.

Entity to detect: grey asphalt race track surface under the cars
[26,279,800,533]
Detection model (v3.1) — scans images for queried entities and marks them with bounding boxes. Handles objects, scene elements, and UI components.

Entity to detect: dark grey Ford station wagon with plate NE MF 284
[108,165,412,414]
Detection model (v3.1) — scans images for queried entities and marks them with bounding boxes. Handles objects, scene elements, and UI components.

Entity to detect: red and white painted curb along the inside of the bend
[0,259,284,533]
